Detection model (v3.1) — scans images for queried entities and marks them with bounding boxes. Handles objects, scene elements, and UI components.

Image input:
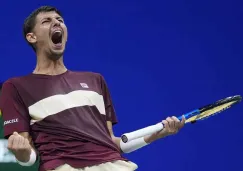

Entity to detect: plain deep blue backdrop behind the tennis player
[0,0,243,171]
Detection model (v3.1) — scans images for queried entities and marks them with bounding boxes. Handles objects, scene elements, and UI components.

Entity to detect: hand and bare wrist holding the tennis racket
[145,116,186,143]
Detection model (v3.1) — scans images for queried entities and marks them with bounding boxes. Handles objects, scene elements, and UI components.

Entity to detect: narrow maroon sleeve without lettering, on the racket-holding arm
[98,76,118,125]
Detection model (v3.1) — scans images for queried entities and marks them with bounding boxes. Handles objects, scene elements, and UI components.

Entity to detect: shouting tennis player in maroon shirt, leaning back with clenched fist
[0,6,185,171]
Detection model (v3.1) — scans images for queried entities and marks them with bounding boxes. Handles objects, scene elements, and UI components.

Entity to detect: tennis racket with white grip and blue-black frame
[121,95,242,143]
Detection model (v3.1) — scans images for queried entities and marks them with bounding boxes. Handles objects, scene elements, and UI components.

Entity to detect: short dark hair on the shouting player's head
[23,6,62,51]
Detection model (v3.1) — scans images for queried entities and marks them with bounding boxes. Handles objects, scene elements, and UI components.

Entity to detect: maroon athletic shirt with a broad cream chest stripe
[0,70,126,171]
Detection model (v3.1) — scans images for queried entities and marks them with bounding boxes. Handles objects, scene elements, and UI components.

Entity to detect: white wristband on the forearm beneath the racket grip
[120,137,148,153]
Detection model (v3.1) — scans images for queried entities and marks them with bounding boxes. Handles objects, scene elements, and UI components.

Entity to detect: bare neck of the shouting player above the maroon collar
[33,52,67,75]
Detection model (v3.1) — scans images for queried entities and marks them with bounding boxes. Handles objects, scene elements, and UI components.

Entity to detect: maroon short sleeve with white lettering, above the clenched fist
[0,81,30,138]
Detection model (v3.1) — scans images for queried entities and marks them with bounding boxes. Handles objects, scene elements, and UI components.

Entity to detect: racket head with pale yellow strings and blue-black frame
[184,95,242,123]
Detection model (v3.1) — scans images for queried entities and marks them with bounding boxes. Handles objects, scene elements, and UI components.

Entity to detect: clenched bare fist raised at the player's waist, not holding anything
[8,132,31,162]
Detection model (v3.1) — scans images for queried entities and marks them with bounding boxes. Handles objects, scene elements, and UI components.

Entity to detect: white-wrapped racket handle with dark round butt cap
[121,123,164,143]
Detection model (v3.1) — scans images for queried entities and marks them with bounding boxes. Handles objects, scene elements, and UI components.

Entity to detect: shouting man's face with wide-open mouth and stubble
[28,11,67,60]
